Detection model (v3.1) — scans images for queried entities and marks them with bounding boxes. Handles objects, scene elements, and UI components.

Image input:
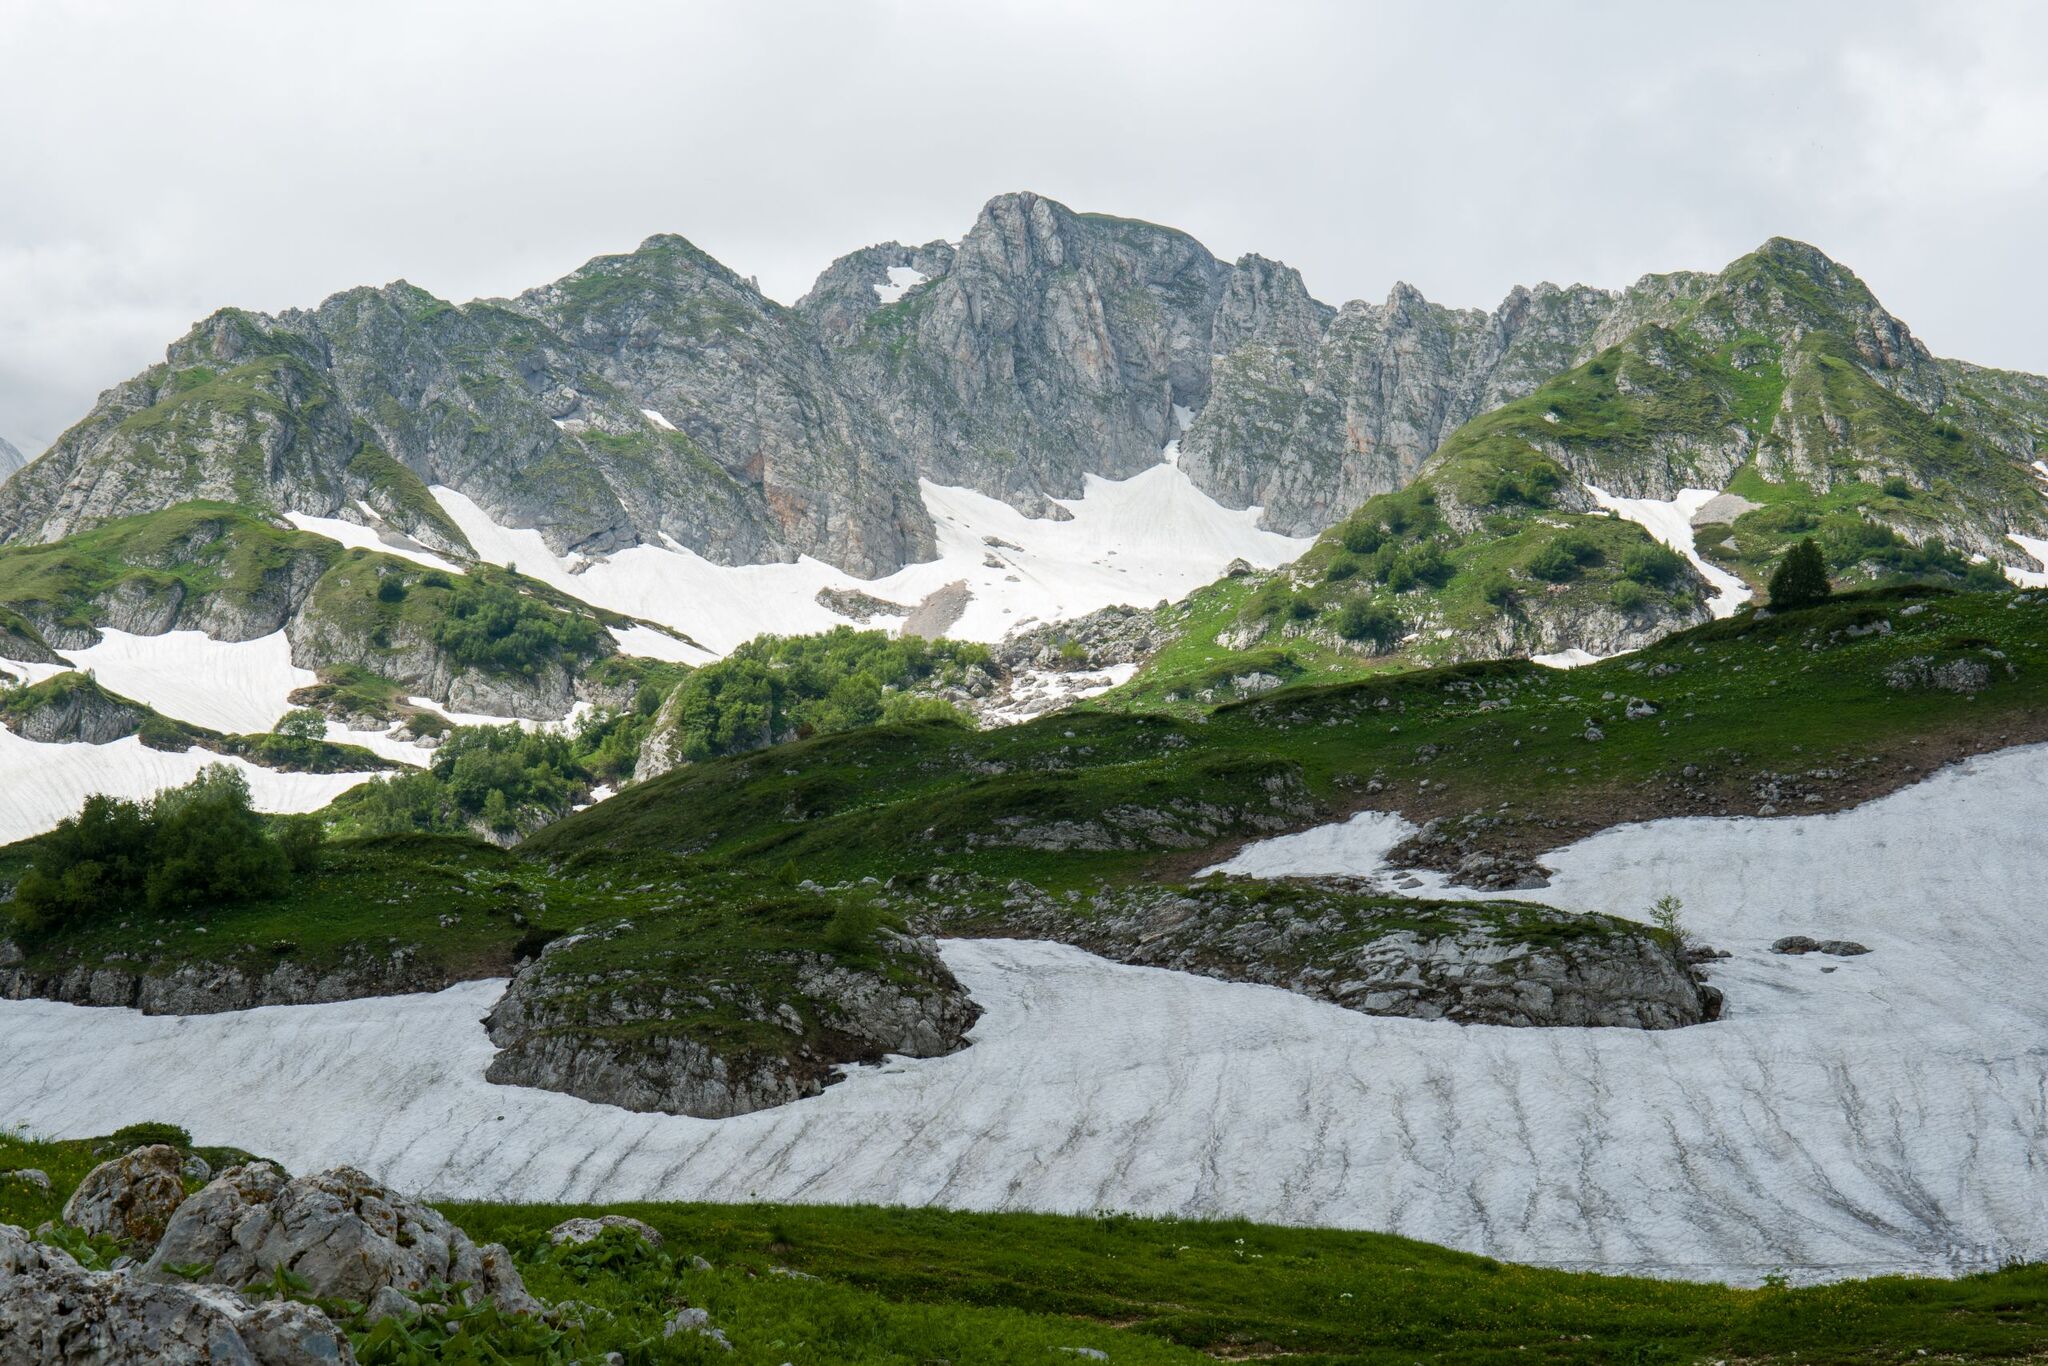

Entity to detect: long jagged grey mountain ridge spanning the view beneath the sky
[0,205,2048,610]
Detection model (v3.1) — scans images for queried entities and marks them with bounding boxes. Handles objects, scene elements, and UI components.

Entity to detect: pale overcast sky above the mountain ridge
[0,0,2048,455]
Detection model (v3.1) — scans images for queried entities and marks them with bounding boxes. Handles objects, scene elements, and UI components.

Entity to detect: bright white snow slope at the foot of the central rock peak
[434,463,1311,655]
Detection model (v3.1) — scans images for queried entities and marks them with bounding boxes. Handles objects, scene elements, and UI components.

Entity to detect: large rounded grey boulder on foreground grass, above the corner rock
[141,1161,541,1315]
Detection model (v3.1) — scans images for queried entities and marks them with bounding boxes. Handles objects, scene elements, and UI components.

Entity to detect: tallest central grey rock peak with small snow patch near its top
[797,195,1229,512]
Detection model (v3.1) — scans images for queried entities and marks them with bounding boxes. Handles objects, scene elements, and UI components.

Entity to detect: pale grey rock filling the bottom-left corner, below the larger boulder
[0,1225,356,1366]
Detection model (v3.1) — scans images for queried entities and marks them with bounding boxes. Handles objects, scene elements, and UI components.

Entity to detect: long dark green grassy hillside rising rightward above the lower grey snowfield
[528,590,2048,887]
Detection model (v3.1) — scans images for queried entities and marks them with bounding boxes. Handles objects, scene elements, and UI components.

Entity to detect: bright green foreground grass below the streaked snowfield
[0,1135,2048,1366]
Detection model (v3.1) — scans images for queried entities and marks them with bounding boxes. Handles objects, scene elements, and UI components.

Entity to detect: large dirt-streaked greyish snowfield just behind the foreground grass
[0,745,2048,1282]
